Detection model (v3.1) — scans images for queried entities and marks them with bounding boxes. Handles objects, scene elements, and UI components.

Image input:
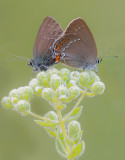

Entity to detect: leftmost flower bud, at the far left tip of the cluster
[1,97,14,109]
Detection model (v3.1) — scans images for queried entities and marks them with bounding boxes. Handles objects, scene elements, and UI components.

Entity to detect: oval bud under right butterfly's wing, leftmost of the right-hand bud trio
[79,72,90,87]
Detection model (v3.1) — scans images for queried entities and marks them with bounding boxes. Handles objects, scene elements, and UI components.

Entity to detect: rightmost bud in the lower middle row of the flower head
[65,86,80,102]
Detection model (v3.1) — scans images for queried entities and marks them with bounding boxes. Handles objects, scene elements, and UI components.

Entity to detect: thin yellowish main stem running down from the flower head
[57,108,70,159]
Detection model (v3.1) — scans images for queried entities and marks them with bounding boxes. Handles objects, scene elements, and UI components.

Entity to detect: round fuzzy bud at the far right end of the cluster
[91,82,105,94]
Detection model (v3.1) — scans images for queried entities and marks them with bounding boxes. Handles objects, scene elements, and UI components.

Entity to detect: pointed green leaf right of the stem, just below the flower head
[64,106,83,121]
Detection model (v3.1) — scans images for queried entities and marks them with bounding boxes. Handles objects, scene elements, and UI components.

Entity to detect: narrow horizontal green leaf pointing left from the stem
[34,120,59,127]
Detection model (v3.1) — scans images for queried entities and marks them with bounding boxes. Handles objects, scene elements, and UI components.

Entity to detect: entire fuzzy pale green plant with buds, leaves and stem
[1,68,105,160]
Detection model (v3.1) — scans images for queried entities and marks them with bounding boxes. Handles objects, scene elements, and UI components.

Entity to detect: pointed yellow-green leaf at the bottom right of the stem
[68,141,85,159]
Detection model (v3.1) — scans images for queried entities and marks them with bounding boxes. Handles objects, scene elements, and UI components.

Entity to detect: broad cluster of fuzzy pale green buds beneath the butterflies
[1,68,105,112]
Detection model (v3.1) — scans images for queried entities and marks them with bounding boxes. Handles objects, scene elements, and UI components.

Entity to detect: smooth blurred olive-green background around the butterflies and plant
[0,0,125,160]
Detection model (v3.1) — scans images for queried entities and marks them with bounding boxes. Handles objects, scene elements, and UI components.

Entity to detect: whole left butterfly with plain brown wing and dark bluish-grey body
[28,17,63,71]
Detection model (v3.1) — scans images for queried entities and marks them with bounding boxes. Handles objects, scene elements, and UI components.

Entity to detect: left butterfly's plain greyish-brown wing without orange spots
[33,16,63,57]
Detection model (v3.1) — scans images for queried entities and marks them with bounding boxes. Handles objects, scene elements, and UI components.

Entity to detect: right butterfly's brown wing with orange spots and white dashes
[55,18,97,68]
